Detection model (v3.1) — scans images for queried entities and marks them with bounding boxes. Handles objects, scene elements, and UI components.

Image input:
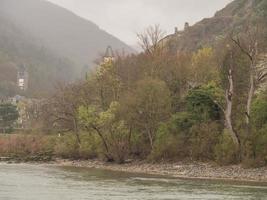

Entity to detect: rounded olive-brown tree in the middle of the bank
[127,78,171,149]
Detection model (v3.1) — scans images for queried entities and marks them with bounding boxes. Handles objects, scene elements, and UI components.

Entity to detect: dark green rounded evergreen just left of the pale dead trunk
[186,83,222,122]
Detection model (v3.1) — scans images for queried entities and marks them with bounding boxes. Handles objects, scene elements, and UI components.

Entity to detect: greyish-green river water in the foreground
[0,164,267,200]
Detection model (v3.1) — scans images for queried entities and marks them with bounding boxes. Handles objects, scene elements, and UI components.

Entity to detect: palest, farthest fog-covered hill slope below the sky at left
[0,0,133,69]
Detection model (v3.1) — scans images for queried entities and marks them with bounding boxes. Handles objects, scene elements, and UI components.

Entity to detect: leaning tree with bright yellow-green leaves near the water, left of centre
[79,102,129,163]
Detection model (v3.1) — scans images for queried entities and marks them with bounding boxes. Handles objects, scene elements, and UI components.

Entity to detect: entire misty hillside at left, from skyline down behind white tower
[0,0,132,96]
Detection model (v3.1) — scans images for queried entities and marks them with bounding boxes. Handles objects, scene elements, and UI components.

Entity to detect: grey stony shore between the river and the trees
[50,160,267,183]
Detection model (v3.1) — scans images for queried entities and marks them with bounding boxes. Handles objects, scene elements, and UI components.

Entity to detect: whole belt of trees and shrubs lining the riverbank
[0,1,267,167]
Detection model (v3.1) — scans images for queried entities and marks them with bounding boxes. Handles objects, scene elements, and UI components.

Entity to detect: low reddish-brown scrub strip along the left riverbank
[0,133,98,162]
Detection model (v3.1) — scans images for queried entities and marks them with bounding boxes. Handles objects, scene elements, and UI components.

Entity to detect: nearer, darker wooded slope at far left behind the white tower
[0,13,75,97]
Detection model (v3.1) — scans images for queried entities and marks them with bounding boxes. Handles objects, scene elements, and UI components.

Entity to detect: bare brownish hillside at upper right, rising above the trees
[171,0,267,51]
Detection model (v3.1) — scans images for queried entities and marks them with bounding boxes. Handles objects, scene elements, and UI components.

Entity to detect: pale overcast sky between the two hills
[45,0,232,45]
